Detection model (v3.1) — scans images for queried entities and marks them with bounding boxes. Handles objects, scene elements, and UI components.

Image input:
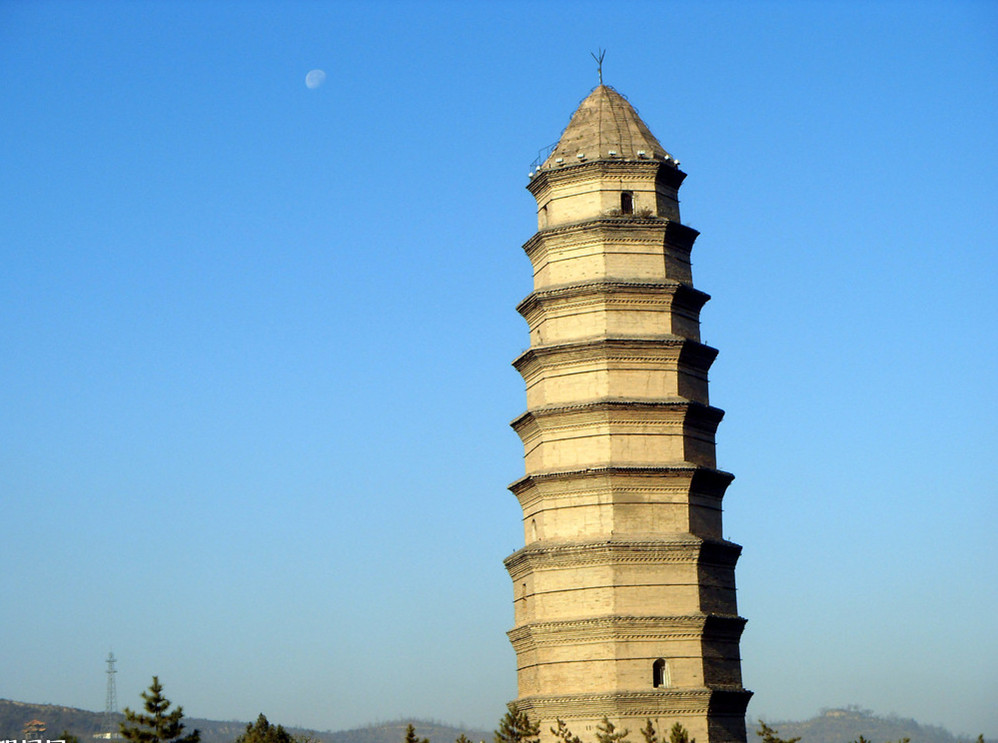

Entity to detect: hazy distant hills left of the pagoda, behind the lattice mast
[0,699,492,743]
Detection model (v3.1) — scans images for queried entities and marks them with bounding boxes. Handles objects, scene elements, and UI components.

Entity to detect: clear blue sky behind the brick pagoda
[0,0,998,738]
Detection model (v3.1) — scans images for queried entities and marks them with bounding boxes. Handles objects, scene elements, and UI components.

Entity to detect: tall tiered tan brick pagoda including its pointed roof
[506,85,751,743]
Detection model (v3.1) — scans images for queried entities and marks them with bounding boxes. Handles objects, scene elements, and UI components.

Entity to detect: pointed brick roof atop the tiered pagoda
[542,85,672,168]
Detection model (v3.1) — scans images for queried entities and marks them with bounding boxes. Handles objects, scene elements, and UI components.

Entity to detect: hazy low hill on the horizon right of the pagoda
[760,706,988,743]
